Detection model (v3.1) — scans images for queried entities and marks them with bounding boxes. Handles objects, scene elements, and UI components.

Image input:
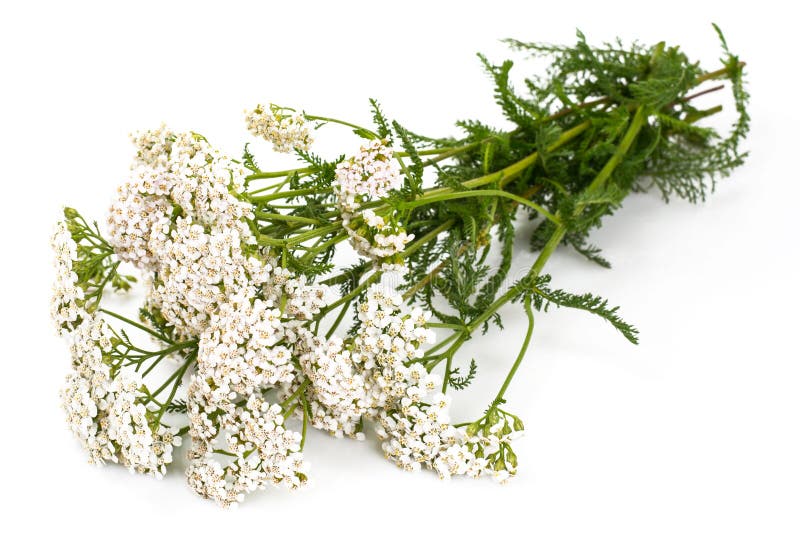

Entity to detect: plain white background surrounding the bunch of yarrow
[0,0,800,533]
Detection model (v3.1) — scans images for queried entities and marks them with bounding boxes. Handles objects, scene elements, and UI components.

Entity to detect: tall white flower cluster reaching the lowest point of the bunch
[187,294,330,506]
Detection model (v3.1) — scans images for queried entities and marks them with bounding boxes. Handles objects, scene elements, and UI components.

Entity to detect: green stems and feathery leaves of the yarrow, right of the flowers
[242,30,749,401]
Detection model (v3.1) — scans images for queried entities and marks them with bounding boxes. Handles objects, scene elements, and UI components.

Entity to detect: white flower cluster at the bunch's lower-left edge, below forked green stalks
[61,315,181,478]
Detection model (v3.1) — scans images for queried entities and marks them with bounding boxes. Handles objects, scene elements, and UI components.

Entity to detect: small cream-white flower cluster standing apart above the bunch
[245,104,313,152]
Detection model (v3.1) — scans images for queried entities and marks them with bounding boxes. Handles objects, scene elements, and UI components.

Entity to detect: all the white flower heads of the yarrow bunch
[51,118,518,506]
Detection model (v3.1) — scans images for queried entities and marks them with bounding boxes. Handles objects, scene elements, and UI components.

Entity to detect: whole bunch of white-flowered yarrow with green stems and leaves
[51,28,749,506]
